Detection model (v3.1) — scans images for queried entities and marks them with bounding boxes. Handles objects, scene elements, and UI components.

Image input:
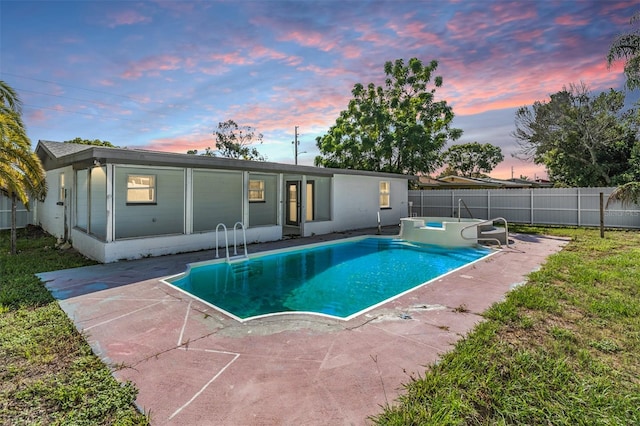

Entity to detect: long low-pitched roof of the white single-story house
[35,140,417,180]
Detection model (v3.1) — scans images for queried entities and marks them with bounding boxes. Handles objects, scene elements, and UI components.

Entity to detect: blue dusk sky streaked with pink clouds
[0,0,640,178]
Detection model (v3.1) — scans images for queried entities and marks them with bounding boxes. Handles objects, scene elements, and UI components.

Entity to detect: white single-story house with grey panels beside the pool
[35,140,413,263]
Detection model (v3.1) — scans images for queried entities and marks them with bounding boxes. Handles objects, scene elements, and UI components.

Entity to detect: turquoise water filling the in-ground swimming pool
[167,238,491,320]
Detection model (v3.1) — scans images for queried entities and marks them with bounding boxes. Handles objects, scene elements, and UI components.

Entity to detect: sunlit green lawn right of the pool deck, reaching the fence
[371,227,640,425]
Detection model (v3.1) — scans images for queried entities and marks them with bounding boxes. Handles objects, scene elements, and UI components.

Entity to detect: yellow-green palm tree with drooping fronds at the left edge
[0,80,47,254]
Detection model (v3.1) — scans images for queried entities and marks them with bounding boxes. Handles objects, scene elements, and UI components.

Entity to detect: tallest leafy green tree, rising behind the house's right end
[315,58,462,175]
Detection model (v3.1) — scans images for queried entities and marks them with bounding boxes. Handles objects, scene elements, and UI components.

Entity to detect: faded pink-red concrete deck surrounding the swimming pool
[38,226,567,425]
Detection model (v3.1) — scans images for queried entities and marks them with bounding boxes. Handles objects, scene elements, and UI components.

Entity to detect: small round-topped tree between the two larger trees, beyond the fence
[442,142,504,177]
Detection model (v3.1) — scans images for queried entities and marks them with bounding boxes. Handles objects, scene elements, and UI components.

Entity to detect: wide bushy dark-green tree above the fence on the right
[513,83,638,186]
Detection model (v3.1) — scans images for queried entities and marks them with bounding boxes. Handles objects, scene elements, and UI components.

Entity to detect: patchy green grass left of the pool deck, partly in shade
[0,227,149,425]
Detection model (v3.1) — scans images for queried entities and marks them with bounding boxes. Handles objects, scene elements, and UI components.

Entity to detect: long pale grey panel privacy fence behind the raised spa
[409,188,640,228]
